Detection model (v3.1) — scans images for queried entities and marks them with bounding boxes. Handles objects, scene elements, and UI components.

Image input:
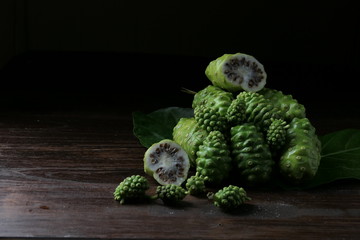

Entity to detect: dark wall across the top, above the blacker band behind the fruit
[0,0,360,65]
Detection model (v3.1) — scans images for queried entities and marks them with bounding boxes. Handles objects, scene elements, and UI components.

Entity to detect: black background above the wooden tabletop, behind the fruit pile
[0,0,360,116]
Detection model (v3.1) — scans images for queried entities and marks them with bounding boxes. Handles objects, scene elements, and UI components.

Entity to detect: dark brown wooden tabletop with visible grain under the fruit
[0,113,360,239]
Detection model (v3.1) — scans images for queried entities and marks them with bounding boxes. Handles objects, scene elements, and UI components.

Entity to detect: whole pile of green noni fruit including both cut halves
[113,53,321,212]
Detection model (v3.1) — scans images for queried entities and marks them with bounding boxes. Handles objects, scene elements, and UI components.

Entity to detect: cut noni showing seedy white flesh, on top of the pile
[205,53,267,92]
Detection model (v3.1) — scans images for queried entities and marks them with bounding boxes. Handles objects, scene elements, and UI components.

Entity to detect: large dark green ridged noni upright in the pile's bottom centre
[231,123,275,185]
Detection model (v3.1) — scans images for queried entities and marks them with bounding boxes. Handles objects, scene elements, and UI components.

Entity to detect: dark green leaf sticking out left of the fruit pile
[132,107,194,148]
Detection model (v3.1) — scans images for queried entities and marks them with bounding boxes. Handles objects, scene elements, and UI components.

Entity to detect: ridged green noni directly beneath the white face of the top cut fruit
[237,92,281,130]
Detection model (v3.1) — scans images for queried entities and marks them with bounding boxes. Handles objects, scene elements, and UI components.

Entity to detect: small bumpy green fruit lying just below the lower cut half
[156,184,186,205]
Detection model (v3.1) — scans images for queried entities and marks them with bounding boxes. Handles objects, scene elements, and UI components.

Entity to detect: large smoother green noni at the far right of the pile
[279,118,321,183]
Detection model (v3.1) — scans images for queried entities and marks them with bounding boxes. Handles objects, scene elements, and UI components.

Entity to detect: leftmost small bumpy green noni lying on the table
[114,175,149,204]
